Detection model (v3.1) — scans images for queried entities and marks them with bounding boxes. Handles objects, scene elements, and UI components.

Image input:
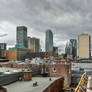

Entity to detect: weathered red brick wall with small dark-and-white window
[49,64,71,85]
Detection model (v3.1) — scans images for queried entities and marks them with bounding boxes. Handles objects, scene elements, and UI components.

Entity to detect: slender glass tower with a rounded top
[45,30,53,52]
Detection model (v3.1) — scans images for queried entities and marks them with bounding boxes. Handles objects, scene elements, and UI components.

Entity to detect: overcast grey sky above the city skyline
[0,0,92,52]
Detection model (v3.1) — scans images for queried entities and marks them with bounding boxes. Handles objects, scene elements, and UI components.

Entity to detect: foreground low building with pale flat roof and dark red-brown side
[6,77,64,92]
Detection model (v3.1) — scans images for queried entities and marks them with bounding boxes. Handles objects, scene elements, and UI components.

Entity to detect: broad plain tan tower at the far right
[78,34,91,58]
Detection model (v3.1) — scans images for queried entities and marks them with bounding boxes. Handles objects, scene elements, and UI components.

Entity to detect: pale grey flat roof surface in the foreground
[5,77,59,92]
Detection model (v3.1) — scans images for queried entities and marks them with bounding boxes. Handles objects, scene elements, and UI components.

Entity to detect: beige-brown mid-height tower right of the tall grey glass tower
[28,37,40,52]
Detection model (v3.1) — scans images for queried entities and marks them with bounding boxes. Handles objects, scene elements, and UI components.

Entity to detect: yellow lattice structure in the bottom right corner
[75,72,88,92]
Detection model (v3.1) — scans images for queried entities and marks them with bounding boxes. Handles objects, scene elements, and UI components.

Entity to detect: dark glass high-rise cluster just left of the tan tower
[65,39,77,57]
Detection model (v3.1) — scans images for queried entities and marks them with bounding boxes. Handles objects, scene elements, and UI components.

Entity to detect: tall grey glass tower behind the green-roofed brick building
[16,26,28,48]
